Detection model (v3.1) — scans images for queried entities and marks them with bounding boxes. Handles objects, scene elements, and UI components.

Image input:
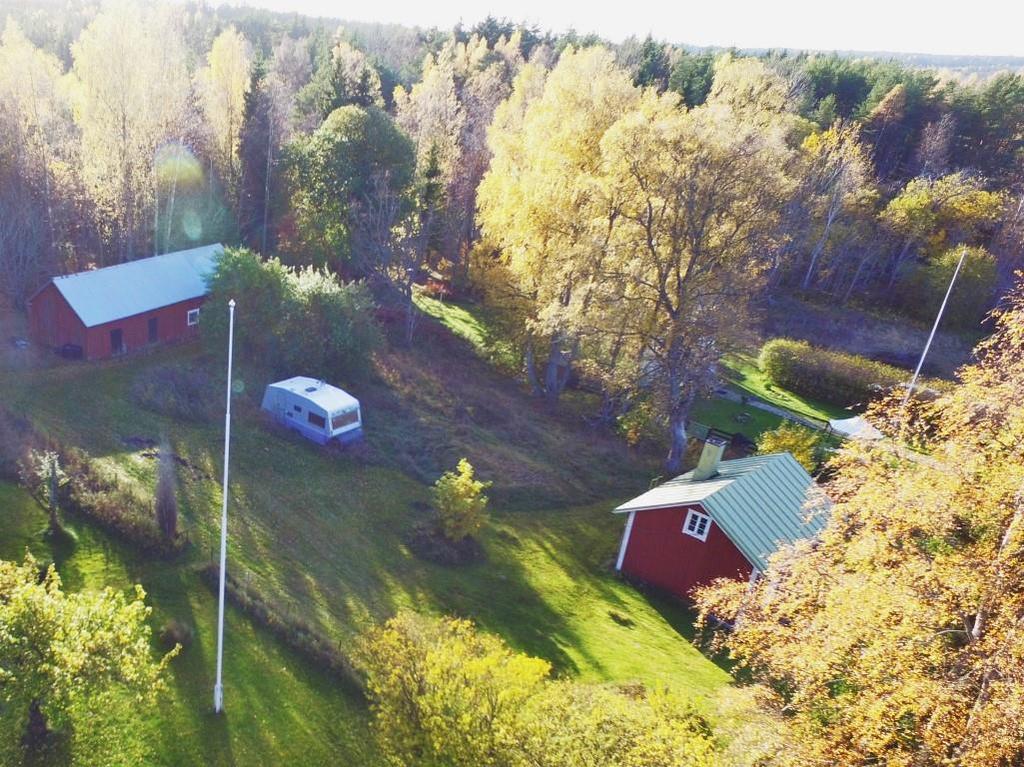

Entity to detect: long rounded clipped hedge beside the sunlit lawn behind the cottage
[759,338,944,408]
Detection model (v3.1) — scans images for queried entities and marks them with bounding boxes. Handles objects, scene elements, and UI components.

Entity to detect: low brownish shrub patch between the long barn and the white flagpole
[131,365,223,421]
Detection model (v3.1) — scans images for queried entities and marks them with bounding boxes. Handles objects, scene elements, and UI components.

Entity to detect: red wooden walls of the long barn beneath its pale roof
[29,283,203,359]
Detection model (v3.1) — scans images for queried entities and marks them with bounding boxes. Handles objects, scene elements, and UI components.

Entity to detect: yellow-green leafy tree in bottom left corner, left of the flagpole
[0,557,177,755]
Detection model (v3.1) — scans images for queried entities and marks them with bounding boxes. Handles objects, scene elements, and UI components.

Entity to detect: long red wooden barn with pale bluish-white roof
[29,245,223,359]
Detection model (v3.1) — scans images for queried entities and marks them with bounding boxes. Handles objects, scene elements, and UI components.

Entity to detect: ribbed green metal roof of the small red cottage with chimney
[615,453,830,572]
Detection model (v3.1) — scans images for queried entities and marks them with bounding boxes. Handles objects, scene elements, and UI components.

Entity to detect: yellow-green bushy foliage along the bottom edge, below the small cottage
[359,612,717,767]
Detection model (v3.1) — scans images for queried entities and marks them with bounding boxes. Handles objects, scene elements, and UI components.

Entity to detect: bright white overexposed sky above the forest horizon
[241,0,1024,56]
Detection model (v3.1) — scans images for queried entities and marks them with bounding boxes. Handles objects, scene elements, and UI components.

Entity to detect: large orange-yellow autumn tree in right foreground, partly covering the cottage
[698,288,1024,766]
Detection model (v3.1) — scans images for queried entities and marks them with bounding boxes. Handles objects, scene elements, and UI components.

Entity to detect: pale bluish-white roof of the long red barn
[53,244,224,328]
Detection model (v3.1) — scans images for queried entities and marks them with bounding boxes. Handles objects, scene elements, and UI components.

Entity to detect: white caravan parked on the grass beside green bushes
[262,376,362,444]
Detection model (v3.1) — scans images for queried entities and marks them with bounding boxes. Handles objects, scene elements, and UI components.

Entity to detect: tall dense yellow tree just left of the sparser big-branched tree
[478,47,640,400]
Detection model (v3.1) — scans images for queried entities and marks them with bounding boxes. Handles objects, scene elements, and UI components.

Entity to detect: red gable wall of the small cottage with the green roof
[622,506,753,599]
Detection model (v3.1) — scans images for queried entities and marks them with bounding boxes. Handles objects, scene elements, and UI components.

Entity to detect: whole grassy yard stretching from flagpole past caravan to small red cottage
[0,321,734,765]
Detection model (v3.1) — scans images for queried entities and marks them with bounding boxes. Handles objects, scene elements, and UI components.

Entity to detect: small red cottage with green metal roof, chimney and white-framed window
[615,435,827,599]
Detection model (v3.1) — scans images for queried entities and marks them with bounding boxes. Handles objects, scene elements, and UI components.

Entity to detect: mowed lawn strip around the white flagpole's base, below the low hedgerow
[0,482,378,767]
